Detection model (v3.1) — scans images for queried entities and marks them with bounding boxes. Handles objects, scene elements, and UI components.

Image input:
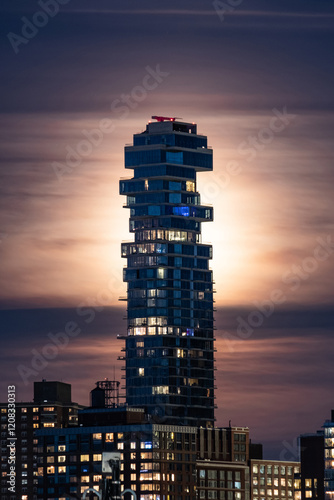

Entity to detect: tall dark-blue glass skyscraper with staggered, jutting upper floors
[120,119,215,427]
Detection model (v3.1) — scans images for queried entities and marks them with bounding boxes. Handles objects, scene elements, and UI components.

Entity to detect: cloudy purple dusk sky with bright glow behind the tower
[0,0,334,458]
